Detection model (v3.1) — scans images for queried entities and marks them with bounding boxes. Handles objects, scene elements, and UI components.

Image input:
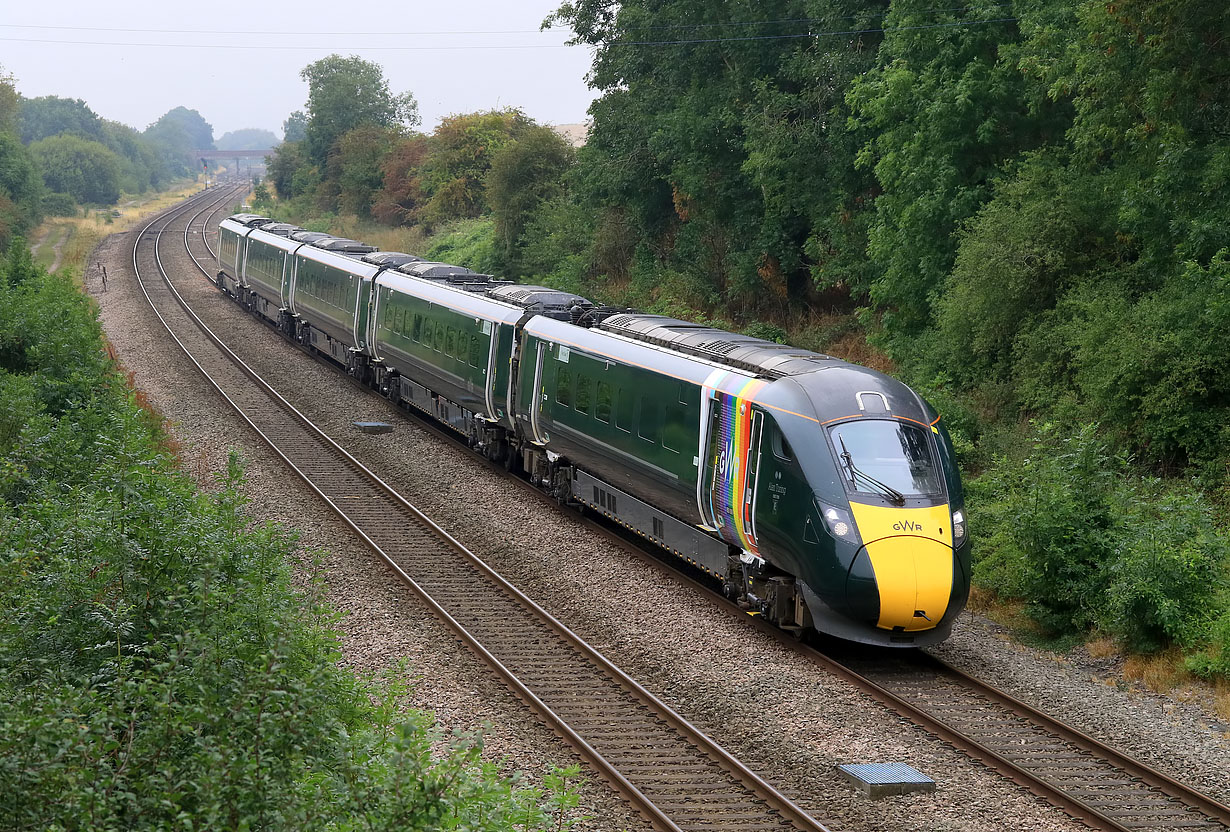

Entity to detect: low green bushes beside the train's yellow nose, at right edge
[967,425,1230,651]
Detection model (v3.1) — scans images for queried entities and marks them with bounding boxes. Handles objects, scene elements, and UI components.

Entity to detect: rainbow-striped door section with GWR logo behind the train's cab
[696,389,764,556]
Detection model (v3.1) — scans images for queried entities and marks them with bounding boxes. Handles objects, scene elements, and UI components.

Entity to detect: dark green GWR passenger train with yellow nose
[216,214,970,647]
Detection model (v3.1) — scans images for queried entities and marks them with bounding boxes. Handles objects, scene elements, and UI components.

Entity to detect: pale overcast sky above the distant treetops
[0,0,593,138]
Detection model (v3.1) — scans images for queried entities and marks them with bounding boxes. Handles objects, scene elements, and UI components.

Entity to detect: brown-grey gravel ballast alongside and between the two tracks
[91,203,1230,830]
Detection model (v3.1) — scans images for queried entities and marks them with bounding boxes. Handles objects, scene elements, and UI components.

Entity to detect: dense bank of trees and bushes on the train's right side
[252,0,1230,673]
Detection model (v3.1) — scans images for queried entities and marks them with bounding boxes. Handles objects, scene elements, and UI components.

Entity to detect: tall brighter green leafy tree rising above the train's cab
[849,0,1064,337]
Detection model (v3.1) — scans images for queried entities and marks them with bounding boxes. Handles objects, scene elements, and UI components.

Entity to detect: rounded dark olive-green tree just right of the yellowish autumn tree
[487,126,576,273]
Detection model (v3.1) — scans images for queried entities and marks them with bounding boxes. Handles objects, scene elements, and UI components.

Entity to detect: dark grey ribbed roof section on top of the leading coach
[598,311,844,378]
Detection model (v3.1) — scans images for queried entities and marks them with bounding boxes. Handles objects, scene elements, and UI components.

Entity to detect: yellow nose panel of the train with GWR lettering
[850,502,953,633]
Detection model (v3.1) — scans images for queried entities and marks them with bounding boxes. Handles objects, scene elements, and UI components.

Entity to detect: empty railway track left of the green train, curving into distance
[132,192,827,832]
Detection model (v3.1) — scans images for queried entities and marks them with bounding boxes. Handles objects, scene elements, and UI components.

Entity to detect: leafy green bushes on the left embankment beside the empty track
[0,252,577,830]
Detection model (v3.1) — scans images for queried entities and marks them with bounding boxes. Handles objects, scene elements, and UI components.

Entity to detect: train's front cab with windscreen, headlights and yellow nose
[755,384,969,646]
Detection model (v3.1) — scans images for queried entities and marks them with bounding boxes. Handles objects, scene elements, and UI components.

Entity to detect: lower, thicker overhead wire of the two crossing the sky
[0,17,1020,52]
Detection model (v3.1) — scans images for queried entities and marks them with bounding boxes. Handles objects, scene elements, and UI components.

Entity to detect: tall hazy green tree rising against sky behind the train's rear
[297,55,419,166]
